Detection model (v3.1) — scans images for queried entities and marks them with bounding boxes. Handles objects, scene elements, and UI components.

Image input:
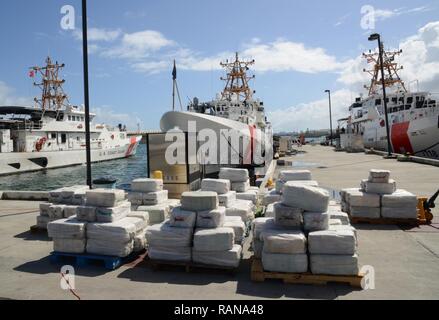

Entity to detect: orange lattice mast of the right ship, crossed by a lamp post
[363,45,407,95]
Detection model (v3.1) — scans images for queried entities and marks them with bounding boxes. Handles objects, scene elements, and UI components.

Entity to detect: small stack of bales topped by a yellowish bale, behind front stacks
[128,178,171,224]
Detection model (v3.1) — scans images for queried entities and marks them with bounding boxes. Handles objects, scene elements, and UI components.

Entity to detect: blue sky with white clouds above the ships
[0,0,439,132]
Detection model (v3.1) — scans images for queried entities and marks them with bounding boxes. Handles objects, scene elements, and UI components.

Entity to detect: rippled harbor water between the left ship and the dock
[0,144,147,191]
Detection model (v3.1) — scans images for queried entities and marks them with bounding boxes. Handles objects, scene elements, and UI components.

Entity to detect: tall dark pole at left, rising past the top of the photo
[82,0,93,189]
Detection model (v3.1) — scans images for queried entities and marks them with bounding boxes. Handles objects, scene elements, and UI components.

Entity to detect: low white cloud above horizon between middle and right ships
[268,89,352,132]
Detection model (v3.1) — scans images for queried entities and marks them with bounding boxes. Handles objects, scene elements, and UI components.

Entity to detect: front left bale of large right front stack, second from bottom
[261,230,306,254]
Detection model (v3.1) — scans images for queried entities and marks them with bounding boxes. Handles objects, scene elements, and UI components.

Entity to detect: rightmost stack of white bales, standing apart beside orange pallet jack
[340,169,418,219]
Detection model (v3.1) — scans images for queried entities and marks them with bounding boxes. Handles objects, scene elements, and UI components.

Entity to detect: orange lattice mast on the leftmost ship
[30,57,68,111]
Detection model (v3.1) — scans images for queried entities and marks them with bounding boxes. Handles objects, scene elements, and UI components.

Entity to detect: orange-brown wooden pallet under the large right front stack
[251,258,363,288]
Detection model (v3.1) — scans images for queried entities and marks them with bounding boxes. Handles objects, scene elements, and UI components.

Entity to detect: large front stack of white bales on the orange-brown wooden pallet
[253,181,358,275]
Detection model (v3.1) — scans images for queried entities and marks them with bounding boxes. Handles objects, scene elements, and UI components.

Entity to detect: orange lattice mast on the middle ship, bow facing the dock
[220,52,255,102]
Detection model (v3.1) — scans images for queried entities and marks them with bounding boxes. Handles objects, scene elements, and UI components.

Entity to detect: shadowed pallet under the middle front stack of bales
[145,257,238,275]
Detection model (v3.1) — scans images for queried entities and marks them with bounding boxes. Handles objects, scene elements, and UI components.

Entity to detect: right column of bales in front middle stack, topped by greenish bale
[191,191,243,267]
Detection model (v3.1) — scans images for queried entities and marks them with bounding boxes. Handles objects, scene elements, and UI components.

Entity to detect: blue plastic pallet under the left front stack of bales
[50,252,140,270]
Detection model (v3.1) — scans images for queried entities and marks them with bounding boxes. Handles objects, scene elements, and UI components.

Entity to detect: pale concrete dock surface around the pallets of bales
[0,146,439,300]
